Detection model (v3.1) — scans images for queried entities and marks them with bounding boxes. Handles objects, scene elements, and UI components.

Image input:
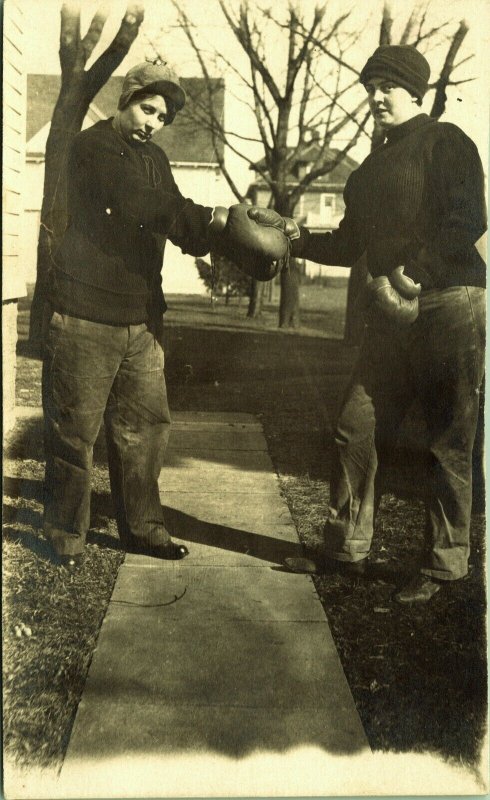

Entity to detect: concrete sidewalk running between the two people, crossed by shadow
[55,414,368,797]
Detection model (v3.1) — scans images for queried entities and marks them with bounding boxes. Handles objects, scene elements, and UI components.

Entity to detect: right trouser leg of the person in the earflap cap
[104,325,170,548]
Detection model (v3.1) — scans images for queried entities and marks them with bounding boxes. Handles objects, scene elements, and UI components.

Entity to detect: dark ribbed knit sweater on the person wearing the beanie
[293,114,486,288]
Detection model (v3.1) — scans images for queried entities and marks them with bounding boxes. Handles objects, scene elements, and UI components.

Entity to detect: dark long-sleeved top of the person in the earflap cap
[50,119,212,325]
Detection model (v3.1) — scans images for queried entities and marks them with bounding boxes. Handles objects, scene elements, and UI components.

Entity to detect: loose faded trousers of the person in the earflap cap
[43,312,170,555]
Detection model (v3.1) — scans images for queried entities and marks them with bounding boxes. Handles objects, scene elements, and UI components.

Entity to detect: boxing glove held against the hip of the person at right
[361,267,422,325]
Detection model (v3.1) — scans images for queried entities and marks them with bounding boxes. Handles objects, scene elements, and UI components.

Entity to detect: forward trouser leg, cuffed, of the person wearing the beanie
[324,328,412,561]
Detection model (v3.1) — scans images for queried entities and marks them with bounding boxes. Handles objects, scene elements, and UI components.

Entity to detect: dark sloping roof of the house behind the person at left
[27,74,225,164]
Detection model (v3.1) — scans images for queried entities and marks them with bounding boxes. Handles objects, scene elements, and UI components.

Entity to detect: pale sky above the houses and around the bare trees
[19,0,490,177]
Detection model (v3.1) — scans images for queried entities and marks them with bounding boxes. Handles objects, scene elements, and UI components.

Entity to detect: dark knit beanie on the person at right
[359,44,430,100]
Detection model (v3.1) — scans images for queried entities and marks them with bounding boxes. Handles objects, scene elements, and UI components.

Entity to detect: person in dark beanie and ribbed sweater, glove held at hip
[249,45,486,604]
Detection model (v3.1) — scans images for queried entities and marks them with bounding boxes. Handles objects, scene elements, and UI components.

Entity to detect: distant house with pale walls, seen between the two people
[247,136,359,275]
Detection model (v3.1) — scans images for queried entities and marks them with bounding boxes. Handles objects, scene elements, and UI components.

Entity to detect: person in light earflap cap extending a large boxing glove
[43,63,288,571]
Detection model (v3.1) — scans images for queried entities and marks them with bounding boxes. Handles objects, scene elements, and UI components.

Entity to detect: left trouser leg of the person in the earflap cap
[43,312,125,555]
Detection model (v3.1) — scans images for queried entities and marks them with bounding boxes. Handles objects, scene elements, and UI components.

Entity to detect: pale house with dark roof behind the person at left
[22,75,236,294]
